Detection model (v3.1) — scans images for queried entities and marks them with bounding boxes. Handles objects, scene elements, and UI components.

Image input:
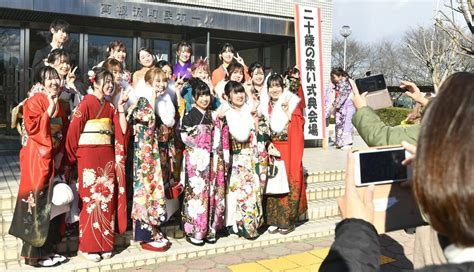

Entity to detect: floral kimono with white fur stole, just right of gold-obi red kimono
[128,84,175,242]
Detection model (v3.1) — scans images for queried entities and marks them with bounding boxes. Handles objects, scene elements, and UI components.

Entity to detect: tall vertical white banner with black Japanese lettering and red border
[295,5,326,140]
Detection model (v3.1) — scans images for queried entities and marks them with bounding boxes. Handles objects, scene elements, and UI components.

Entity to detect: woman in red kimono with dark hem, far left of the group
[9,66,68,267]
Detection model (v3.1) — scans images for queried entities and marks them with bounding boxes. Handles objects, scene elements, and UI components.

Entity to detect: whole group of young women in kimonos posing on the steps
[10,39,307,266]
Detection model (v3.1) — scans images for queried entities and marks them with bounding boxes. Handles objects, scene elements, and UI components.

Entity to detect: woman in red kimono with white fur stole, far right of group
[259,74,308,234]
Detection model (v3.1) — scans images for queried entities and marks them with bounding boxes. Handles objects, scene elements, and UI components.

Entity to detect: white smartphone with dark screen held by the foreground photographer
[354,147,412,186]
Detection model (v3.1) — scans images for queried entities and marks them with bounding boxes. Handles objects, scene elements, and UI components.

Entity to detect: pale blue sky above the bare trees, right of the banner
[333,0,436,42]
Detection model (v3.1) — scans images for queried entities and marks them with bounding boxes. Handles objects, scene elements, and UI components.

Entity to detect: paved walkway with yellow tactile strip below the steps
[125,231,414,272]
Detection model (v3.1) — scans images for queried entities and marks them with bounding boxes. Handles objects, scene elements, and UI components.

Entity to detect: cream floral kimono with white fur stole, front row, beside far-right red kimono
[224,106,268,238]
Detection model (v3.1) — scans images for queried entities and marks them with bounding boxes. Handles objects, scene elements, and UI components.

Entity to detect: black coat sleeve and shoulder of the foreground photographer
[319,219,474,272]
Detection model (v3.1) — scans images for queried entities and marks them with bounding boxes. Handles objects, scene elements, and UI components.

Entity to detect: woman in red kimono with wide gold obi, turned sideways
[66,68,128,261]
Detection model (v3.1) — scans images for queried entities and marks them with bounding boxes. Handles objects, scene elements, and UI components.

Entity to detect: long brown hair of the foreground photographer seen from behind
[413,72,474,247]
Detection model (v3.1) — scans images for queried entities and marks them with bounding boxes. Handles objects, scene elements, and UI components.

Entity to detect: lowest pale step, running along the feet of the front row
[0,217,340,272]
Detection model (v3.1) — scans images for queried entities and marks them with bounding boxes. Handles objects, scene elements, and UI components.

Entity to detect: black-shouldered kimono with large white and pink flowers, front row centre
[181,107,229,240]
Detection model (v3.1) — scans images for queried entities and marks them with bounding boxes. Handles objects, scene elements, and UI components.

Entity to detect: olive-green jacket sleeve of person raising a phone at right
[352,107,420,146]
